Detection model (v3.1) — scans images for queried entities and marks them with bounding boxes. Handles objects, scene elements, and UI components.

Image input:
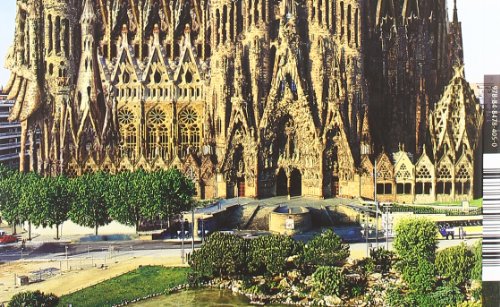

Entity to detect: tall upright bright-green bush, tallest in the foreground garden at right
[394,218,437,293]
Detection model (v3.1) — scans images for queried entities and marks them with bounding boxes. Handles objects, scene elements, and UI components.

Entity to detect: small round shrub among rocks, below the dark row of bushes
[312,266,345,296]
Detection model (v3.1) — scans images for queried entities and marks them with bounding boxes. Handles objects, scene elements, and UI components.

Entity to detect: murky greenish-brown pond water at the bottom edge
[130,289,254,307]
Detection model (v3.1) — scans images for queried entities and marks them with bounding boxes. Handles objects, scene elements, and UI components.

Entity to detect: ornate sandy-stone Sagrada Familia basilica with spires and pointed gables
[6,0,483,203]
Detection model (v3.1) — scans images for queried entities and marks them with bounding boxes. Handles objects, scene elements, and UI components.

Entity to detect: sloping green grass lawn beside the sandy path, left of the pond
[59,266,189,307]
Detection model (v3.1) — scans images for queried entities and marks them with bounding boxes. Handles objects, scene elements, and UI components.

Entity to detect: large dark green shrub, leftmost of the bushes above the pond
[189,233,248,283]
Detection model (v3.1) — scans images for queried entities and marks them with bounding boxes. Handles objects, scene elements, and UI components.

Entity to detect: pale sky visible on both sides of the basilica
[0,0,500,85]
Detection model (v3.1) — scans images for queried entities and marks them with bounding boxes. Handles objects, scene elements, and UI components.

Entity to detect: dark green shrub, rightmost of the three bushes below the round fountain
[303,229,350,267]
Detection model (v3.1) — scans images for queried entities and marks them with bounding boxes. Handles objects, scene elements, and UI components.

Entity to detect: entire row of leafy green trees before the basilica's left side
[0,167,195,238]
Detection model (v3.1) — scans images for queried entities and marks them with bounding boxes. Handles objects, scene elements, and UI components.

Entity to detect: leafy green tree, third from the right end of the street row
[68,172,111,235]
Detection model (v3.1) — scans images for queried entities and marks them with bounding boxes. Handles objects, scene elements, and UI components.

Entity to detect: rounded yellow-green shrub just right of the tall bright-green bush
[436,243,474,287]
